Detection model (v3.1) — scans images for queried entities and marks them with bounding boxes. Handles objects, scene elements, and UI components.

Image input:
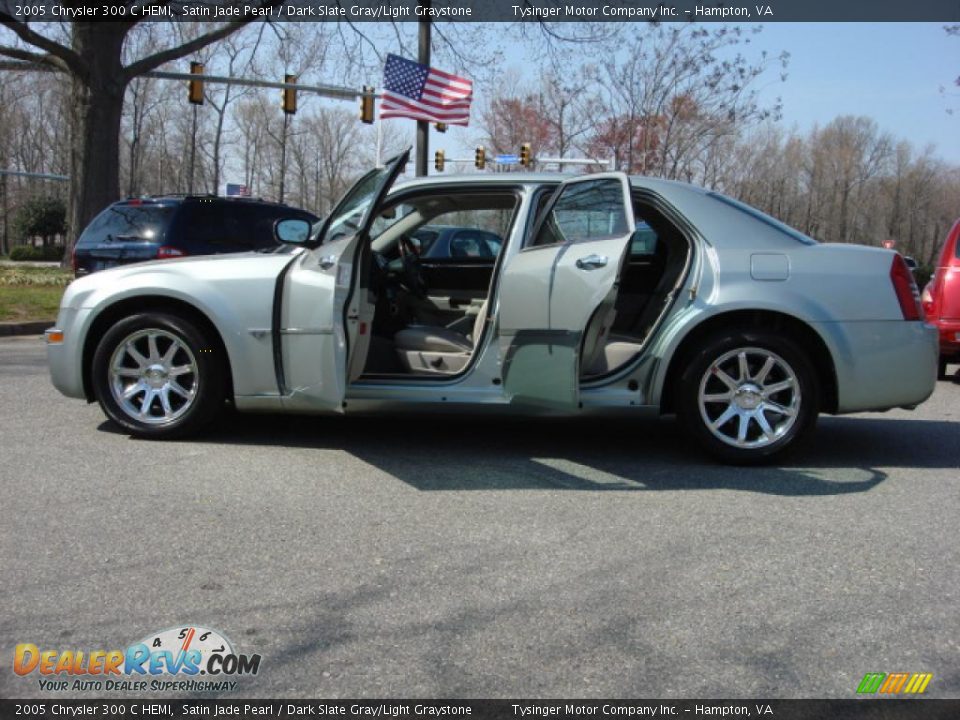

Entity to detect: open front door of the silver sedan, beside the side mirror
[274,150,410,411]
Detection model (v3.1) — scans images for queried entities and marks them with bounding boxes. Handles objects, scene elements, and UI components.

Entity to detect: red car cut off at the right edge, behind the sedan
[922,220,960,379]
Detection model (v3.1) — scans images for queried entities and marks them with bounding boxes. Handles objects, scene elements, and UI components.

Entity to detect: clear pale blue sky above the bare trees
[431,23,960,166]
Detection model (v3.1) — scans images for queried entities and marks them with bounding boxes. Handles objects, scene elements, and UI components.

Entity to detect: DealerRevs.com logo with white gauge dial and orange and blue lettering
[13,625,260,692]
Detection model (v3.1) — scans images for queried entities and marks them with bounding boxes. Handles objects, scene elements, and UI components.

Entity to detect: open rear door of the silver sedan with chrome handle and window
[499,173,634,410]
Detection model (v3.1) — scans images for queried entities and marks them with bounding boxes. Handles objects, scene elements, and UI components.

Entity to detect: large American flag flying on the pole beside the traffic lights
[380,55,473,125]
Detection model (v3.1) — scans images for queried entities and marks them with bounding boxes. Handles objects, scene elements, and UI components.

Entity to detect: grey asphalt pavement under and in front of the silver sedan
[0,338,960,698]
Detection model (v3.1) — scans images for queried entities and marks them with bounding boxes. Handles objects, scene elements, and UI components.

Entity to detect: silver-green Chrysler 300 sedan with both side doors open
[47,153,937,463]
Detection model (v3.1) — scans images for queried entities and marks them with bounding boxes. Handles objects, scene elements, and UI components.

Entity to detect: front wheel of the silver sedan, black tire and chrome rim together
[93,312,224,439]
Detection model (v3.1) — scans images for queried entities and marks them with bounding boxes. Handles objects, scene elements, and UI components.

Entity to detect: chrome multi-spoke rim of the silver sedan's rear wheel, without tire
[697,347,802,449]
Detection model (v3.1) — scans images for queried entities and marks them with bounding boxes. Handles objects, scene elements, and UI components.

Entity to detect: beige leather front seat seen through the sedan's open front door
[393,302,487,375]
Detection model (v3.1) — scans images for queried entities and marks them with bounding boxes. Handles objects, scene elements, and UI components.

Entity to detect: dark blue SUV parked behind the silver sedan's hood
[73,195,317,277]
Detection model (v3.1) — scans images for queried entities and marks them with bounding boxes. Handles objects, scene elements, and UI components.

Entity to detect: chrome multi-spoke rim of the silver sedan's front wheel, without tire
[108,328,200,425]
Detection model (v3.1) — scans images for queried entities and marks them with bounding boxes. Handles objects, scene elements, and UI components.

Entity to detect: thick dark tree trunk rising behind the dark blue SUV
[64,22,127,264]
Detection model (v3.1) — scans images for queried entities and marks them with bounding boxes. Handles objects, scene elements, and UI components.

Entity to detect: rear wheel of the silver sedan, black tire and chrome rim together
[676,331,820,465]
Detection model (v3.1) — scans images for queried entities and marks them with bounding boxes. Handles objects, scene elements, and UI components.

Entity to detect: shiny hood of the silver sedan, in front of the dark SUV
[62,252,293,307]
